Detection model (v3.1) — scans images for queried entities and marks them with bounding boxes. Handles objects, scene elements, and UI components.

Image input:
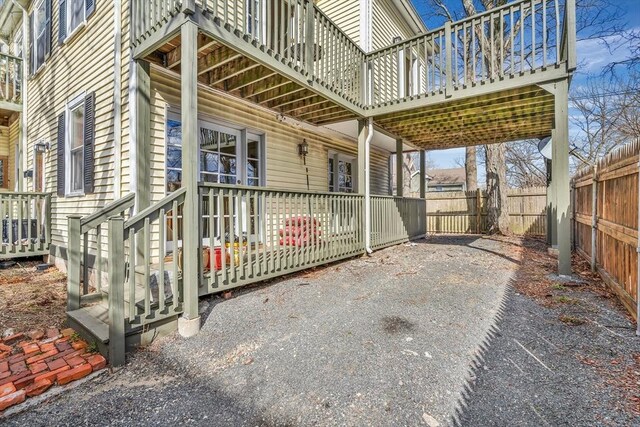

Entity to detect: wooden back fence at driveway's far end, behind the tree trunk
[427,187,547,236]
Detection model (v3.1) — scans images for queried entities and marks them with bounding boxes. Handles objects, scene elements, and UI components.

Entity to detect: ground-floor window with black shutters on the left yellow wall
[58,93,95,196]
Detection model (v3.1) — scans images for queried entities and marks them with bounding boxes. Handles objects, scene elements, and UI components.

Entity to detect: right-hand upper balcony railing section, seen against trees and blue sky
[367,0,568,107]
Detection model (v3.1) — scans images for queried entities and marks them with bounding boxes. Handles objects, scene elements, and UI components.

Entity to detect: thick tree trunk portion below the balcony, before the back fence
[485,144,509,234]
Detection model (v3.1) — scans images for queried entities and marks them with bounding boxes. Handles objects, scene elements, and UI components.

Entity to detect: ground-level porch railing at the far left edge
[0,193,51,259]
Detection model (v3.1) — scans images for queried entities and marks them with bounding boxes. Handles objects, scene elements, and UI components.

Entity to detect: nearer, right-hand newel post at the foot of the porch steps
[107,216,125,366]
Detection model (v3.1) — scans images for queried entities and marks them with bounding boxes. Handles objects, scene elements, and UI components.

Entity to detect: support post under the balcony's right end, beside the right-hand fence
[551,79,571,275]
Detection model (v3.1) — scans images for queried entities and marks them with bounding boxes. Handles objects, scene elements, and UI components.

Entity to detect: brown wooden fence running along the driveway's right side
[571,141,640,319]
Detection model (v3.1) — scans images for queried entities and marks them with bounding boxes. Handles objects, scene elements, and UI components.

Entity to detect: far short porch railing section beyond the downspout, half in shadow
[371,196,427,249]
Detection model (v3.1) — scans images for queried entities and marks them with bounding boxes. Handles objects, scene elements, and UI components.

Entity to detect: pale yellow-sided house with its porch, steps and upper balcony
[0,0,574,364]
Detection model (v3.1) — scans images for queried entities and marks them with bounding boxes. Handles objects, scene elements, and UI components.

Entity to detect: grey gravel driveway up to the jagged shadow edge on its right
[4,239,516,426]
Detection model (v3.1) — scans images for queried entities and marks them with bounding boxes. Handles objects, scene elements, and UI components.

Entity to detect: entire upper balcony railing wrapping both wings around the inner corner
[132,0,575,112]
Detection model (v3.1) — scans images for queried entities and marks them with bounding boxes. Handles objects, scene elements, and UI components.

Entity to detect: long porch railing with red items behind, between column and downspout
[200,184,364,293]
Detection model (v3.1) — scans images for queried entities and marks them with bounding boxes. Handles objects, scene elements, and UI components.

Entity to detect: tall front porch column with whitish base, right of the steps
[178,21,202,337]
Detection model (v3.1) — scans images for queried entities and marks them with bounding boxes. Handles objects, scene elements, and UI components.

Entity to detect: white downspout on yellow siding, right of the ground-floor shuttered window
[113,0,122,200]
